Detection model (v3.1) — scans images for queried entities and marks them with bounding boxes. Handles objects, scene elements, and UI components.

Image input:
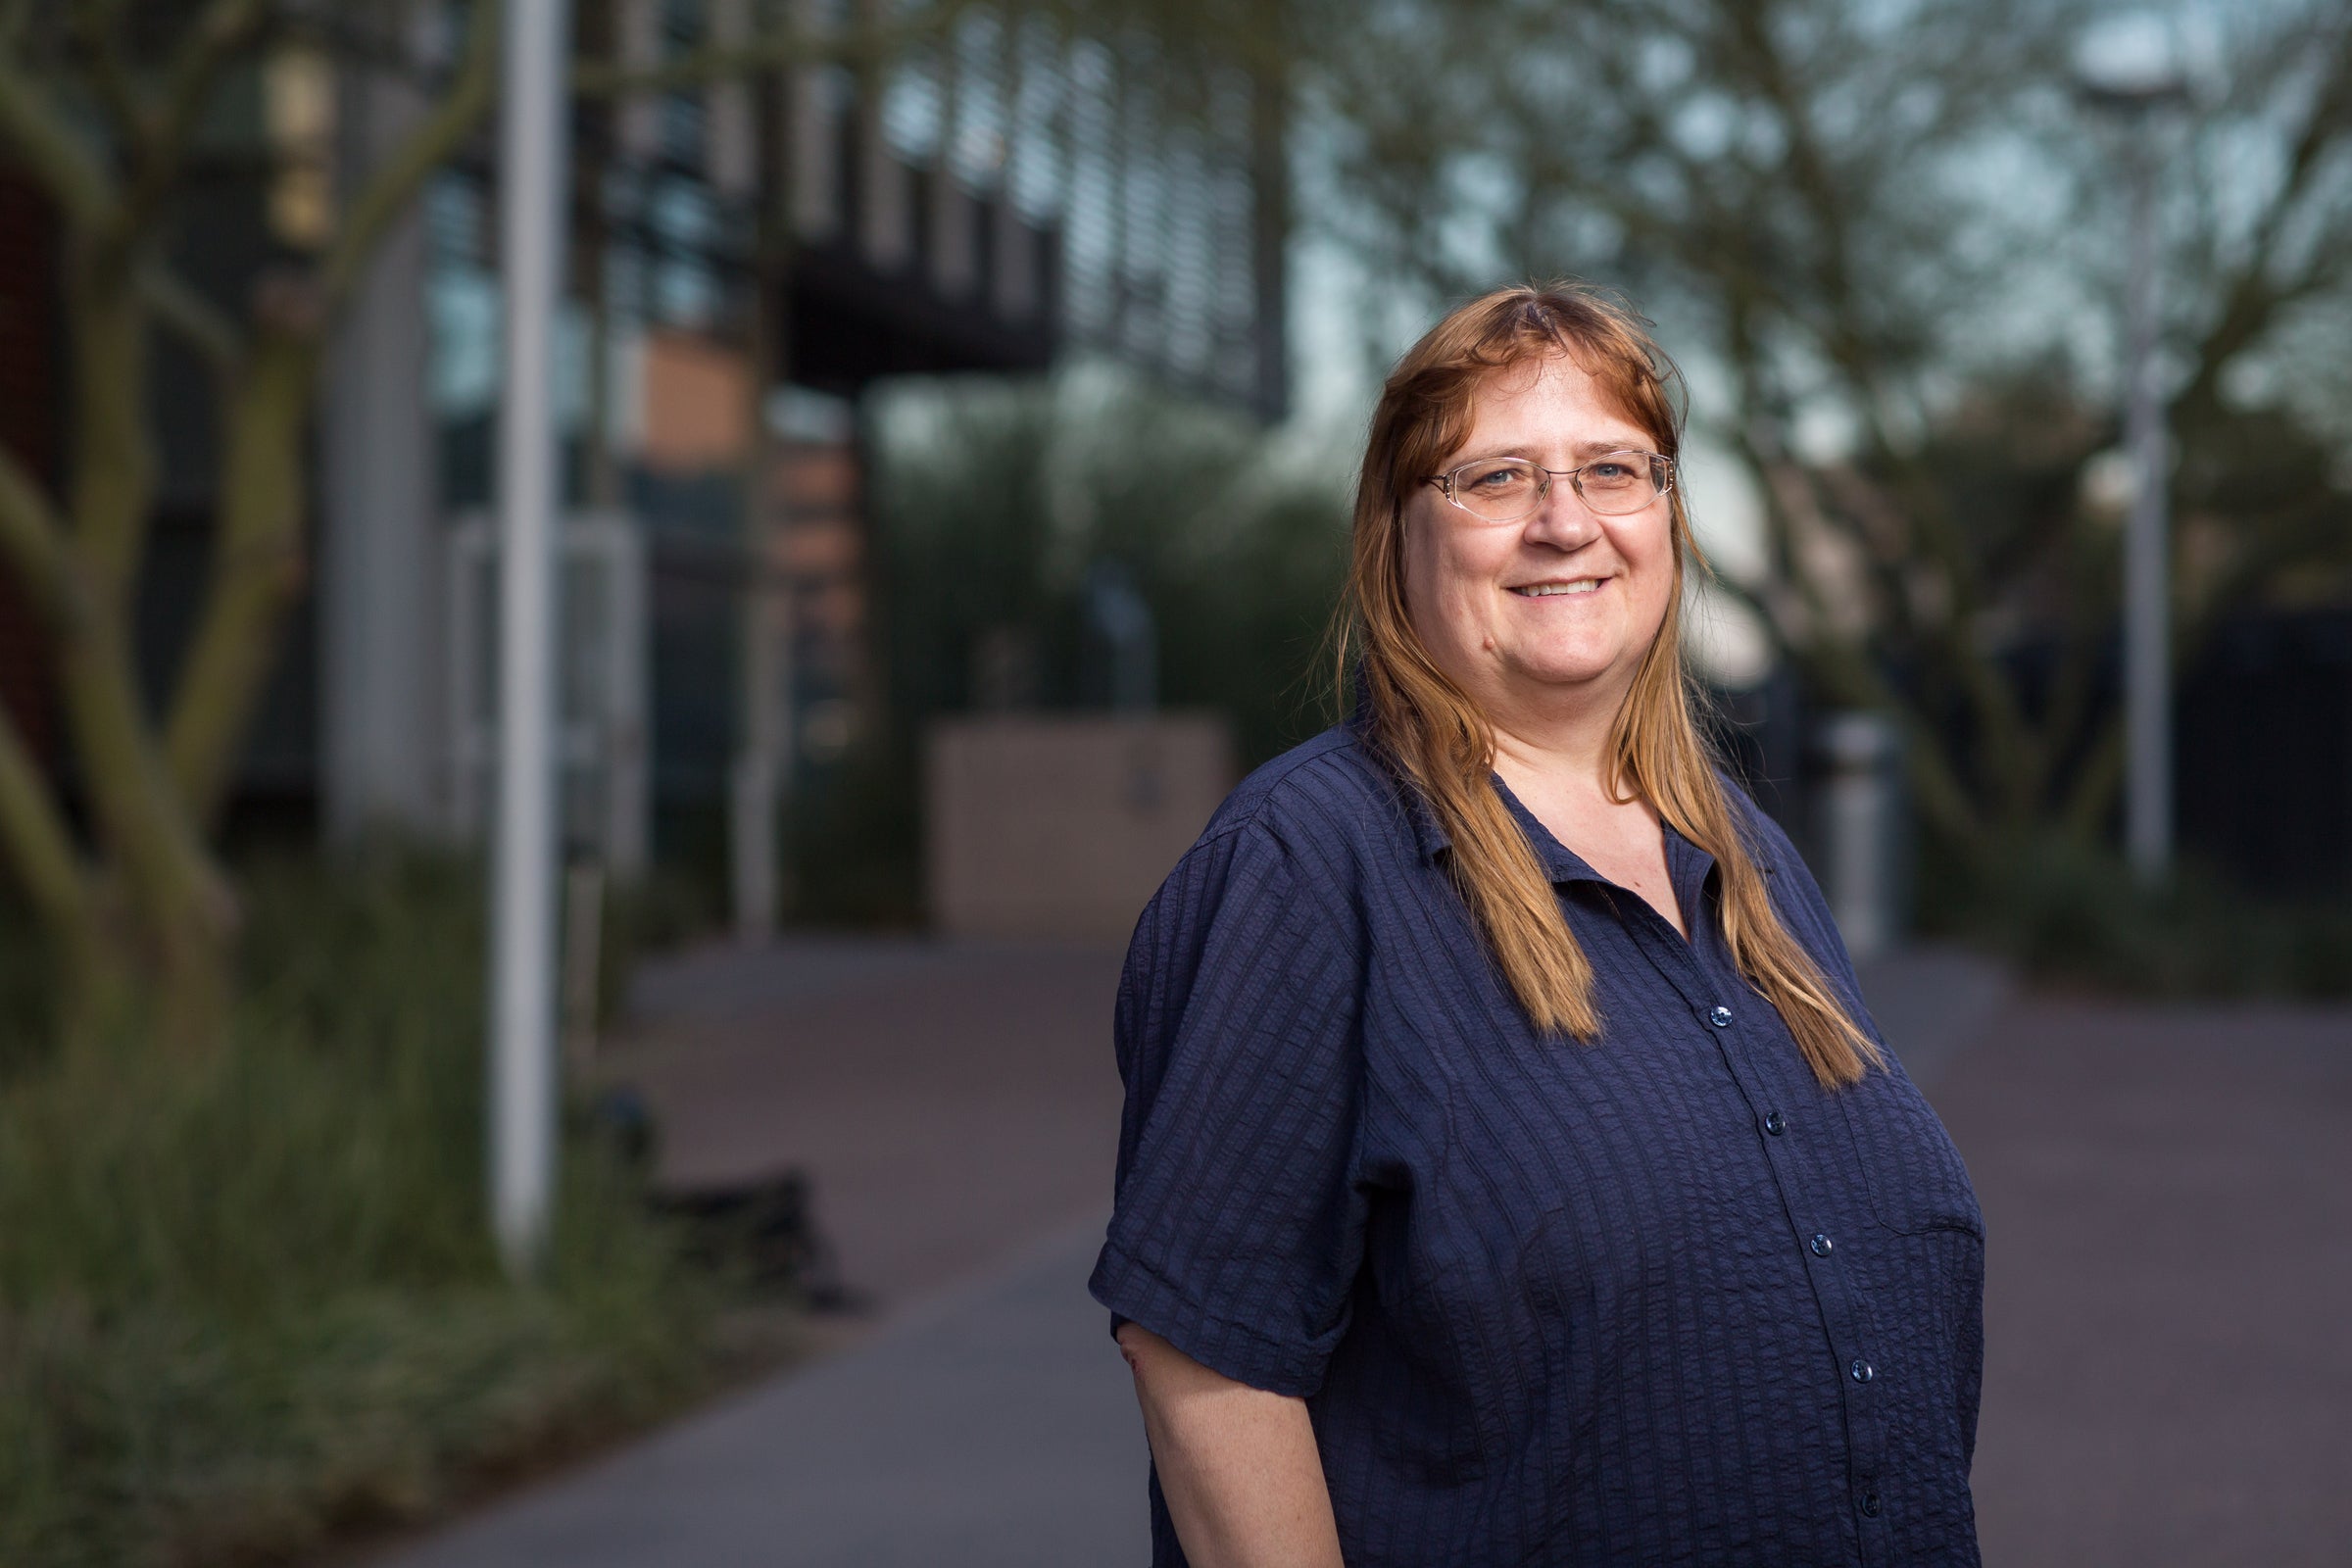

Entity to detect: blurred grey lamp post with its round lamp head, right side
[2075,17,2187,884]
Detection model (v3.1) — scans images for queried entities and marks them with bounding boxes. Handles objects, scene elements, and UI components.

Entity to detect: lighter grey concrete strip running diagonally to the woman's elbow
[380,1218,1151,1568]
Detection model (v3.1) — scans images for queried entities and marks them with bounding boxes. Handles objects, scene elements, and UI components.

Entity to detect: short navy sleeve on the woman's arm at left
[1092,823,1366,1394]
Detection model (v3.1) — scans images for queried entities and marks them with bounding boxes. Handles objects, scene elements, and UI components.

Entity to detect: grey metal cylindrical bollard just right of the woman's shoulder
[1813,712,1907,961]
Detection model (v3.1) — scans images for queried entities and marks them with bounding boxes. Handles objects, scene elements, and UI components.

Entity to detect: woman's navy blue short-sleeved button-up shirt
[1092,726,1985,1568]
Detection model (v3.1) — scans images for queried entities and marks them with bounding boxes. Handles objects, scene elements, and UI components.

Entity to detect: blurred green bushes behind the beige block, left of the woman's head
[875,367,1354,761]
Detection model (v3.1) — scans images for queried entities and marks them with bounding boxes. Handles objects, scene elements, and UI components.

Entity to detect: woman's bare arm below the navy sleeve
[1119,1324,1341,1568]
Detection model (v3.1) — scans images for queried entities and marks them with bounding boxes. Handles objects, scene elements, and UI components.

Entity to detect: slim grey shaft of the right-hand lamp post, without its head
[2124,139,2174,884]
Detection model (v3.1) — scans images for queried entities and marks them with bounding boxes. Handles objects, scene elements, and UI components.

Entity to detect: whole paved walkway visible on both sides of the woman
[376,941,2352,1568]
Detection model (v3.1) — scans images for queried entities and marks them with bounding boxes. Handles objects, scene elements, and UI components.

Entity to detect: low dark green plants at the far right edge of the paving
[1927,835,2352,999]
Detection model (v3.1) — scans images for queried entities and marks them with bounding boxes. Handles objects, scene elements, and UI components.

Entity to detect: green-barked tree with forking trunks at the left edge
[0,0,959,1042]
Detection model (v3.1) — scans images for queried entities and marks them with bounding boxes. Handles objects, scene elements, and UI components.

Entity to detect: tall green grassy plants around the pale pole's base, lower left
[0,860,771,1568]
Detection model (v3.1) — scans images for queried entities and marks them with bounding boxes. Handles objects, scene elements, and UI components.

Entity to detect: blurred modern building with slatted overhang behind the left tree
[0,0,1287,893]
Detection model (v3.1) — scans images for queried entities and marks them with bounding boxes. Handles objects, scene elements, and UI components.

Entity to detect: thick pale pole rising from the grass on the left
[477,0,571,1279]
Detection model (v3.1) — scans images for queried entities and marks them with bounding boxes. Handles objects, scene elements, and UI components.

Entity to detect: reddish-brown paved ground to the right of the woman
[1936,999,2352,1568]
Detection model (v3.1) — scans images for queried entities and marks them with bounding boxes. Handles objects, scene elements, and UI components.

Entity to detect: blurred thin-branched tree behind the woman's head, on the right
[1322,0,2352,856]
